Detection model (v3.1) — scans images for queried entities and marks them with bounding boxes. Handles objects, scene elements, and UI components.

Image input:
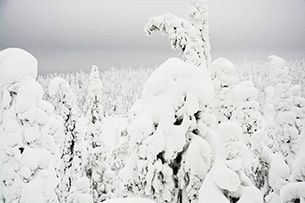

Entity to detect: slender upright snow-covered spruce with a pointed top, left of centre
[84,66,118,202]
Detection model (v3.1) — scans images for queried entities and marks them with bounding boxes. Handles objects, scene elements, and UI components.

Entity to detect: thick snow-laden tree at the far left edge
[0,48,58,203]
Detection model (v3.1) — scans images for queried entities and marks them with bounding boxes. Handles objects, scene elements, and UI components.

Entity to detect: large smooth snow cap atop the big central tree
[143,58,214,110]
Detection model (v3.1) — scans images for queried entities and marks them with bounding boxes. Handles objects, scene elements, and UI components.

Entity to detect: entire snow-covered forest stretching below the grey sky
[0,0,305,203]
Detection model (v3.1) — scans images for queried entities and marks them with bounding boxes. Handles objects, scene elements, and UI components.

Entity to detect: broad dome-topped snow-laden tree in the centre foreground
[120,58,217,202]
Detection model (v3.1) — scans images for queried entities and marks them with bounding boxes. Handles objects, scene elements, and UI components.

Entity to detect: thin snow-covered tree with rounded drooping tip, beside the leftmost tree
[49,78,85,203]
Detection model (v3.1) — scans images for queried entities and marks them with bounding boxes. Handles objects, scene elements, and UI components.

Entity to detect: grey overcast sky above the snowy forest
[0,0,305,73]
